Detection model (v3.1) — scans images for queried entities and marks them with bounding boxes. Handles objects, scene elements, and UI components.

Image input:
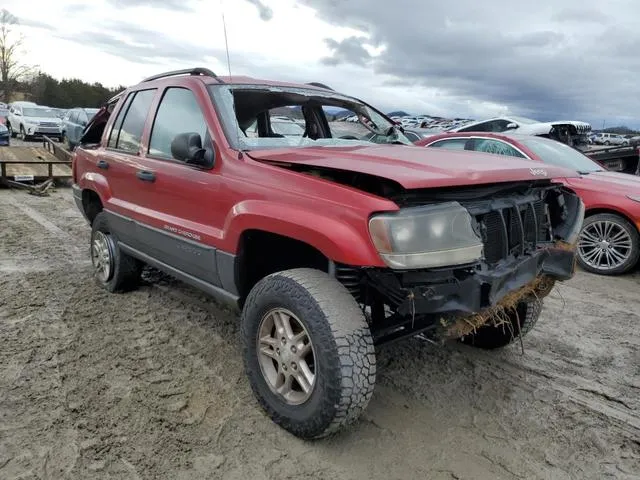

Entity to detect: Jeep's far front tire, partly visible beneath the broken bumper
[460,299,542,350]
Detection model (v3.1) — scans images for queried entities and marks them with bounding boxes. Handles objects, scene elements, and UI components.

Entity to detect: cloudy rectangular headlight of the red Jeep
[369,202,483,269]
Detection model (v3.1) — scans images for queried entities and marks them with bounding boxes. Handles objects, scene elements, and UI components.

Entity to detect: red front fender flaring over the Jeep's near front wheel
[224,200,385,267]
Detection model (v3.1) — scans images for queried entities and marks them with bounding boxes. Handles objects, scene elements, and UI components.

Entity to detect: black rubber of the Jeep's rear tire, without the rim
[89,212,143,293]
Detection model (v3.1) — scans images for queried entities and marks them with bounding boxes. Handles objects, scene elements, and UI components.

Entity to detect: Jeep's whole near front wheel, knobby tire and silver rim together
[241,268,376,439]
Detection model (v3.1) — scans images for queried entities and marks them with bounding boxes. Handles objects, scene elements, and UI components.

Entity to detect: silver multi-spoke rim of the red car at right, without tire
[578,220,633,270]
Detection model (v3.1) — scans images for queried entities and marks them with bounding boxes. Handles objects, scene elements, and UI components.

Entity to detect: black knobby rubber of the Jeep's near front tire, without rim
[242,268,376,439]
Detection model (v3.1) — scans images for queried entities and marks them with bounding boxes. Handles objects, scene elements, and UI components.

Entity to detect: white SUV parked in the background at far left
[6,102,62,140]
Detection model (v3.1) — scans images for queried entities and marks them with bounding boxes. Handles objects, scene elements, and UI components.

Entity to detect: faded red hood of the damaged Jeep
[247,144,578,189]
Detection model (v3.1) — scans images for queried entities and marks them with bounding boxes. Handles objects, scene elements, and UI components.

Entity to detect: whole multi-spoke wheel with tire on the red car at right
[578,213,640,275]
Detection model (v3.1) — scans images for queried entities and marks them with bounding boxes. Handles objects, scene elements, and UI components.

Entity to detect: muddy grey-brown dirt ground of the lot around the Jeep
[0,189,640,480]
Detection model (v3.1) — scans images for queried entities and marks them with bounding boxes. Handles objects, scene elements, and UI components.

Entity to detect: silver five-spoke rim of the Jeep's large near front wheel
[257,308,316,405]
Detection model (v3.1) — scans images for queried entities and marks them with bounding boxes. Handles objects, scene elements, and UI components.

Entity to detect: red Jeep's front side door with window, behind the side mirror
[126,87,222,286]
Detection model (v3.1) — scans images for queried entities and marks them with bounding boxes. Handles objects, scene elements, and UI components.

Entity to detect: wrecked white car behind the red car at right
[447,116,591,145]
